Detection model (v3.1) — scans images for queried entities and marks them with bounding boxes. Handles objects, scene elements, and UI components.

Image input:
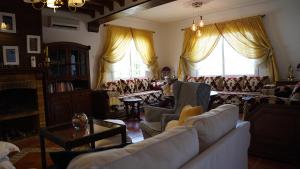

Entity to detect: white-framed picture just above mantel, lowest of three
[2,46,19,65]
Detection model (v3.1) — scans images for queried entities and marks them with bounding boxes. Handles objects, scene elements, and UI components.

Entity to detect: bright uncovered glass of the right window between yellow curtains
[196,37,255,76]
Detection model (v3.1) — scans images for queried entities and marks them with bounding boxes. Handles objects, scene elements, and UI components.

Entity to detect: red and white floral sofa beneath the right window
[186,76,270,113]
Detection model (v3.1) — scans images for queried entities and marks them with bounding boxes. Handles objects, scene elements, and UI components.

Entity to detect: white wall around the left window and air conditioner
[42,9,166,88]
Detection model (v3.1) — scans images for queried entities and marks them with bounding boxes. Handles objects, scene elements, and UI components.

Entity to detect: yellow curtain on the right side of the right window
[216,16,279,81]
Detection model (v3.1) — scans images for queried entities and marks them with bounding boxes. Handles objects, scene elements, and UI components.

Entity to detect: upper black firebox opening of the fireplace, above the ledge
[0,88,38,114]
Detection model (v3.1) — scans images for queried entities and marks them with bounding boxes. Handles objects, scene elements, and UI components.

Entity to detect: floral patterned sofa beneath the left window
[101,78,162,113]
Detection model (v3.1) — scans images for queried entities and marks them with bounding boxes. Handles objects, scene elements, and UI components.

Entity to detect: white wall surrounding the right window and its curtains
[162,0,300,79]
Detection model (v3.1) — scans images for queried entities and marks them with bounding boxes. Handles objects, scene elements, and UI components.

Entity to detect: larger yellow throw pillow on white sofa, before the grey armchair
[178,105,203,125]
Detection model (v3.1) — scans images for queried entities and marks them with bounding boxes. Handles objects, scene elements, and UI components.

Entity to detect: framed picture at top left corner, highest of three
[0,12,16,33]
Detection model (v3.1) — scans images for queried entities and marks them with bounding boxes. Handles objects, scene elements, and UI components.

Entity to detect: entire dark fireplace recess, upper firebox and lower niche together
[0,88,39,141]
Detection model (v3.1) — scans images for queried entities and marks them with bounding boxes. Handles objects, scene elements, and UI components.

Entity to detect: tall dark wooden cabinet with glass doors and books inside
[44,42,92,126]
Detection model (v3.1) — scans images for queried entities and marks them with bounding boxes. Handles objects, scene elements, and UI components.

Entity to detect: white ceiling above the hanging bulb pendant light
[134,0,269,23]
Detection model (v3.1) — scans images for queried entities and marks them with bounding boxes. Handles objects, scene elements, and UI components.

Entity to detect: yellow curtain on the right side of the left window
[132,29,159,79]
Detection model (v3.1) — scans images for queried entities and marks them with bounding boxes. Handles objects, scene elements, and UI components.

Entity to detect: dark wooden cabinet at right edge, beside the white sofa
[245,104,300,165]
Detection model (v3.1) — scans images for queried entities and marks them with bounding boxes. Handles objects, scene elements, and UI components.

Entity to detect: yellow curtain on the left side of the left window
[97,26,132,88]
